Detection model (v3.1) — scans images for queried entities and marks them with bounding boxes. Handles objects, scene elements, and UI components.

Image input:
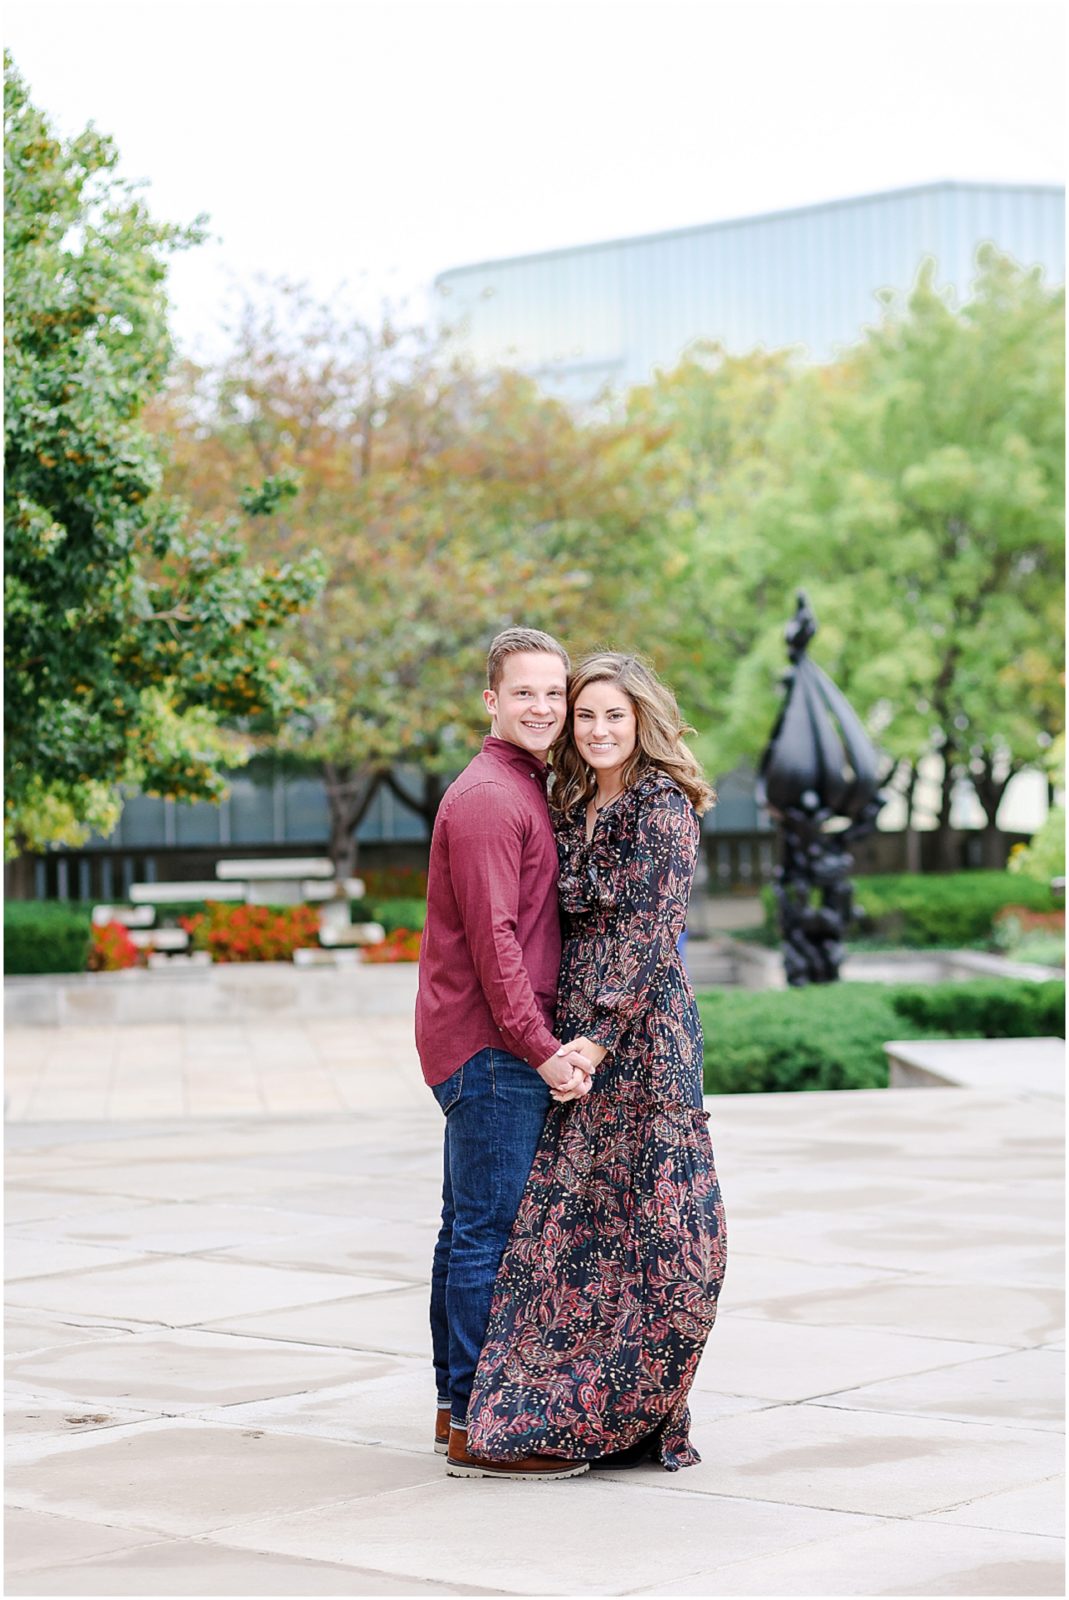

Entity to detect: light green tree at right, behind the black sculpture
[646,248,1064,866]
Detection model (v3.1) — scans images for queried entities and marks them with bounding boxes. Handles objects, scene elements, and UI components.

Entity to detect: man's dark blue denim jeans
[430,1050,549,1427]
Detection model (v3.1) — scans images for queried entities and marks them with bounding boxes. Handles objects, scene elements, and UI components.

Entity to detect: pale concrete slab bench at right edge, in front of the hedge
[883,1038,1066,1098]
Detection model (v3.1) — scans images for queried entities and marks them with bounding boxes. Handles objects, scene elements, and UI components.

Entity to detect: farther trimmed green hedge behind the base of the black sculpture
[762,872,1055,950]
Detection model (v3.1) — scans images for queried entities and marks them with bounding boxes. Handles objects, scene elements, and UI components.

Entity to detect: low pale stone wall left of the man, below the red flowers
[3,962,416,1027]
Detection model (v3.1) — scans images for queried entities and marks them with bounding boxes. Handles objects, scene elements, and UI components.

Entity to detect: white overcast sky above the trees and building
[5,0,1064,354]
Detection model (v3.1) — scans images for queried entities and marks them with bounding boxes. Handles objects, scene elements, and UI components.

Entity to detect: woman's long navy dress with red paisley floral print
[467,771,727,1472]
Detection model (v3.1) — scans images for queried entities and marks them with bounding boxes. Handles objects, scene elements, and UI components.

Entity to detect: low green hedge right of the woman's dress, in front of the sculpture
[698,979,1066,1094]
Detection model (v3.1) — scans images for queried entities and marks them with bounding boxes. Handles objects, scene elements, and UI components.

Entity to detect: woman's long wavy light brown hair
[551,650,717,816]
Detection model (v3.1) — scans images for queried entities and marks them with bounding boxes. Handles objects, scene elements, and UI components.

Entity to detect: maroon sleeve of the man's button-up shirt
[450,784,560,1067]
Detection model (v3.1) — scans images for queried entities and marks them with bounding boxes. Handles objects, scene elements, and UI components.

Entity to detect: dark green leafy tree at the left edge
[5,56,320,854]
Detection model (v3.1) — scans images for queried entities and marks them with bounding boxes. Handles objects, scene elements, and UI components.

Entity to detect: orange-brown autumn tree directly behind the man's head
[157,288,659,870]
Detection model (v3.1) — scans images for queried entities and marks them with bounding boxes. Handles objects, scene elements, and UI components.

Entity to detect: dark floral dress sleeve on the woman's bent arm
[589,789,699,1051]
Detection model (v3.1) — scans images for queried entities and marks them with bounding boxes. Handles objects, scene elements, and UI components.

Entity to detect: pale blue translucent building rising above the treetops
[435,182,1066,402]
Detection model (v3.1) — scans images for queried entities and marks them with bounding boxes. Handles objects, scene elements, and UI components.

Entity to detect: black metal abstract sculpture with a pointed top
[757,589,885,987]
